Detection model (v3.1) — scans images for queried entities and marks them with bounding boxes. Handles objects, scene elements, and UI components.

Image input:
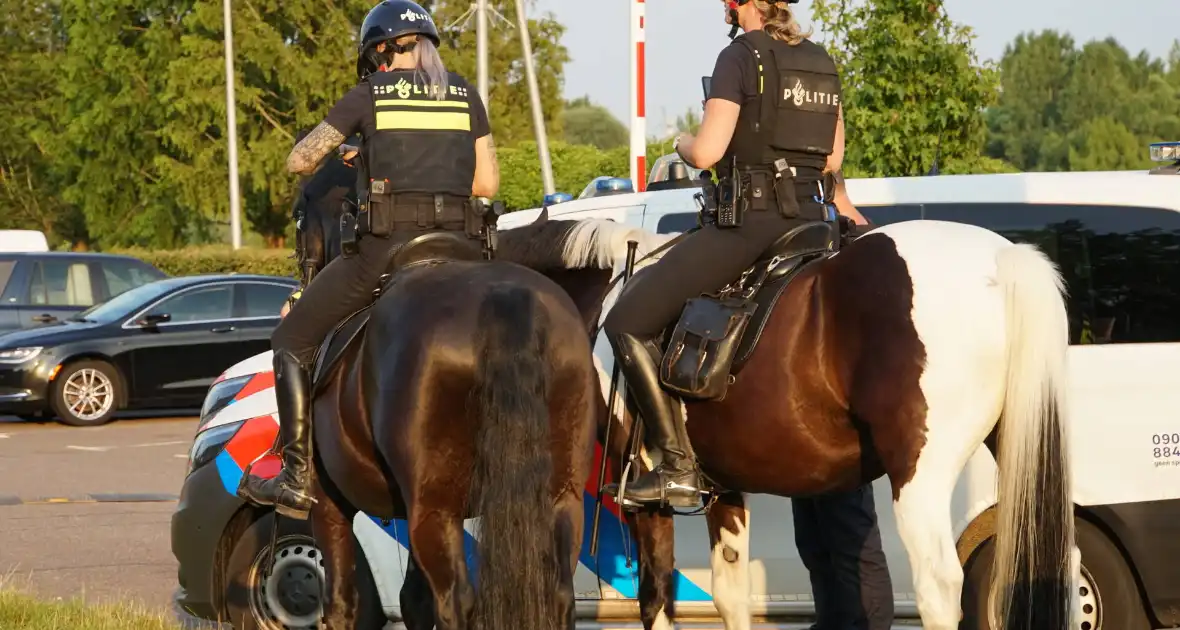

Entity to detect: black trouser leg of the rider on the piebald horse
[603,210,818,339]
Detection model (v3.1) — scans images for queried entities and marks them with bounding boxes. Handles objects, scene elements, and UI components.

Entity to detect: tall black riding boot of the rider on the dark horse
[237,350,313,520]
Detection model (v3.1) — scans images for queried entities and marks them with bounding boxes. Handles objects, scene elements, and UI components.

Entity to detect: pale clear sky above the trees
[528,0,1180,136]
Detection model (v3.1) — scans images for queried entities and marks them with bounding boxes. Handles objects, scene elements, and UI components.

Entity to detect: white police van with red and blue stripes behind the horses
[172,143,1180,630]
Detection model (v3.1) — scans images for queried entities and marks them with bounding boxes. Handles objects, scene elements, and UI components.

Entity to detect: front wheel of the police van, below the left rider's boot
[224,514,325,630]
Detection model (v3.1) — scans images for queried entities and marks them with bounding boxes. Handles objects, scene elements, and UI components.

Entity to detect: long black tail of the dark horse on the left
[471,286,558,630]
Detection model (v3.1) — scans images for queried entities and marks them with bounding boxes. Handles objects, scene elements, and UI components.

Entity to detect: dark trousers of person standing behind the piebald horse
[791,484,893,630]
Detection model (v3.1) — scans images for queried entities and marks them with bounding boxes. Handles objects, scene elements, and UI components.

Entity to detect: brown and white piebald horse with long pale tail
[502,219,1080,630]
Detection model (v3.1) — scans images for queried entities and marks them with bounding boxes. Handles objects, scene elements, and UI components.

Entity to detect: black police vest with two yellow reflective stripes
[362,71,476,197]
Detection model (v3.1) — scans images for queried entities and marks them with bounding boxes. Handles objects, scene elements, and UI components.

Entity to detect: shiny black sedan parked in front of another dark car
[0,274,297,426]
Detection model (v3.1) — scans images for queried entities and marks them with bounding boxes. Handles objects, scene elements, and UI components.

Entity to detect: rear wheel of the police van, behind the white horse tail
[959,518,1152,630]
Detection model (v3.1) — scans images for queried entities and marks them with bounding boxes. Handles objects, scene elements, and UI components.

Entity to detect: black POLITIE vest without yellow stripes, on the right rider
[719,31,840,182]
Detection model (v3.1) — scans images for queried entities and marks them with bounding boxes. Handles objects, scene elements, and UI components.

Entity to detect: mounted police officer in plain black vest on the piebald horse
[603,0,844,506]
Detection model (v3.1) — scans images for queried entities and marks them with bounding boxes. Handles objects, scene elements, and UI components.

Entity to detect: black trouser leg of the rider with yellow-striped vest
[270,230,461,366]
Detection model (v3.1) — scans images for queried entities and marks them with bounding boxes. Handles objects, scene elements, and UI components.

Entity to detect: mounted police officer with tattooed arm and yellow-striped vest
[237,0,499,519]
